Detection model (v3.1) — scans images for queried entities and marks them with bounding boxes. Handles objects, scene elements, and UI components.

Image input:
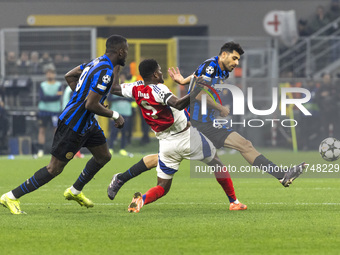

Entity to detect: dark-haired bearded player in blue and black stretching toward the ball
[168,42,305,187]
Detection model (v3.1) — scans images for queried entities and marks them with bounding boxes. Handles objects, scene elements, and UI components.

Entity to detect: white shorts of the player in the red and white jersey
[156,127,216,179]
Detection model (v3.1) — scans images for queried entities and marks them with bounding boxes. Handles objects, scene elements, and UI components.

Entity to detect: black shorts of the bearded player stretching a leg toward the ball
[190,120,234,149]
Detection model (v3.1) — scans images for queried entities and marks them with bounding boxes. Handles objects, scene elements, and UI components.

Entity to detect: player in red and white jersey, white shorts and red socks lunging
[111,59,247,212]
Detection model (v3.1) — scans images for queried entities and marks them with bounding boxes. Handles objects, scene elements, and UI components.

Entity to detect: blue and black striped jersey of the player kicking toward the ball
[189,56,229,122]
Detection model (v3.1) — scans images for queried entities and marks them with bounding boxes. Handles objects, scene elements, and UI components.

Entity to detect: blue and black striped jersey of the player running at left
[59,55,113,134]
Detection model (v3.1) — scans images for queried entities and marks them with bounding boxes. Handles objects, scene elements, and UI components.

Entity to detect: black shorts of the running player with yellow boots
[51,122,106,162]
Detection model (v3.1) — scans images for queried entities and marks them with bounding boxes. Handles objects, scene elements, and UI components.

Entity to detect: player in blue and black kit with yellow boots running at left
[0,35,128,214]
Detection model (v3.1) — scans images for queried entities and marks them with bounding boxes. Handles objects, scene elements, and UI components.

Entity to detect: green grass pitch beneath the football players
[0,147,340,255]
